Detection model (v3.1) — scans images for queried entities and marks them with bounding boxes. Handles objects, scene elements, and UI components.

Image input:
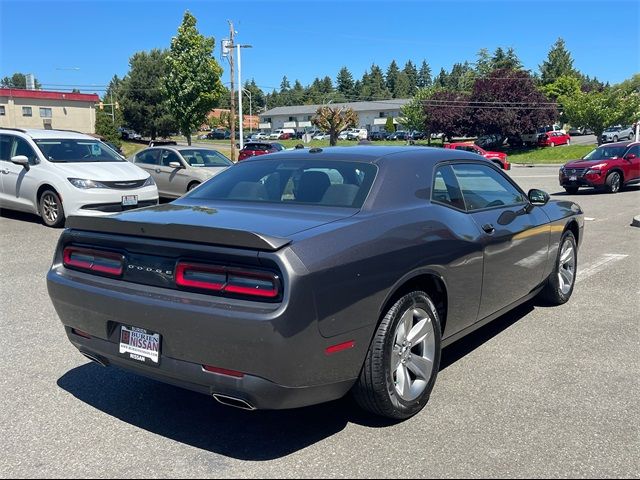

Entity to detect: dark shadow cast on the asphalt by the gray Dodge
[57,302,534,461]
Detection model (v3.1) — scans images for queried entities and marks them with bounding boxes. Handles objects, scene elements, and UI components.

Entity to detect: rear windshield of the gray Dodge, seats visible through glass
[187,160,377,208]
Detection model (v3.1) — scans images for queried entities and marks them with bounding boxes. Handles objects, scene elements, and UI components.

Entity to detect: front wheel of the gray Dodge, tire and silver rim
[539,230,578,305]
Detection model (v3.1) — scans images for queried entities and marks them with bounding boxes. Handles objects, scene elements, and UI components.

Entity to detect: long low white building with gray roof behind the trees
[259,98,411,132]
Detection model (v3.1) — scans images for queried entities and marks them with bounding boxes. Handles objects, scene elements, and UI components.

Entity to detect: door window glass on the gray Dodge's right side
[453,164,526,211]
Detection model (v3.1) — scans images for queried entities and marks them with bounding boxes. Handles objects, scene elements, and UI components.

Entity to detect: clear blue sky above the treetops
[0,0,640,93]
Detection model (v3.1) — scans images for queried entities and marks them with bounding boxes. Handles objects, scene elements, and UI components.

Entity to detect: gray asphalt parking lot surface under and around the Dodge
[0,167,640,478]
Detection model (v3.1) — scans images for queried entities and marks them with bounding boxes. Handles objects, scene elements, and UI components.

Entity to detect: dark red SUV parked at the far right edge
[560,142,640,195]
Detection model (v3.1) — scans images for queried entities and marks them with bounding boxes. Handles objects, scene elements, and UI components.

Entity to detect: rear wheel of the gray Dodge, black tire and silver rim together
[352,291,442,420]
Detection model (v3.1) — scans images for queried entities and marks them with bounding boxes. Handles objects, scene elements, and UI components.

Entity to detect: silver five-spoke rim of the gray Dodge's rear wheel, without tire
[391,308,436,402]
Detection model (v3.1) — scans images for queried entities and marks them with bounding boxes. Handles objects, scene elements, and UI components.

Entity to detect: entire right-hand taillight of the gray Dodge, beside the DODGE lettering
[176,262,280,299]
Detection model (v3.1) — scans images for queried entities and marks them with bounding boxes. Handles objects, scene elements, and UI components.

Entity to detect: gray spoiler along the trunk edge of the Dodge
[65,216,291,252]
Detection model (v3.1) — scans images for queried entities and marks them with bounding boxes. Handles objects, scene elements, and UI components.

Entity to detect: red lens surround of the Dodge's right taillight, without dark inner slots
[176,262,280,298]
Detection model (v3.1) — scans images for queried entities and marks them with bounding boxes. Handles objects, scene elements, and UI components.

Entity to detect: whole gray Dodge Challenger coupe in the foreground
[47,146,584,419]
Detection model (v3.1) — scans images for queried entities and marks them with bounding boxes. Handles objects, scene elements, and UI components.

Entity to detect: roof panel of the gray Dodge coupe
[243,145,478,164]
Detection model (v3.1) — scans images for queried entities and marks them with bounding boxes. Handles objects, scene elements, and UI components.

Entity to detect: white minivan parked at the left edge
[0,128,158,227]
